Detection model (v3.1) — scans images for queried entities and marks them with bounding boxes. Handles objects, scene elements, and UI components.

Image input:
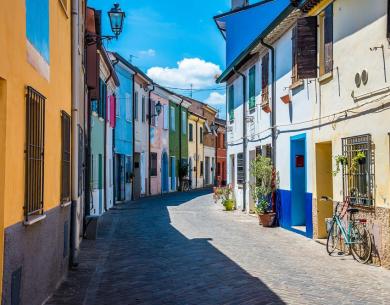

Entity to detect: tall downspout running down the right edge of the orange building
[69,0,80,267]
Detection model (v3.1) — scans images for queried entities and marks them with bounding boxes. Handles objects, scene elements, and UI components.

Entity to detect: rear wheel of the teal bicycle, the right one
[351,223,372,264]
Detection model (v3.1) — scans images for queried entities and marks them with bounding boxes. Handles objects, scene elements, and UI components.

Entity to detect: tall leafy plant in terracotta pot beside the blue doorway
[250,156,278,227]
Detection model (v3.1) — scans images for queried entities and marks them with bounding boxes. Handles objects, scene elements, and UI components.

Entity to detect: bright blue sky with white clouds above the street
[88,0,230,117]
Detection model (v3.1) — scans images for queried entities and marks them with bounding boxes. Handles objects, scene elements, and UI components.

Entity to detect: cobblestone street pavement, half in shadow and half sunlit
[47,191,390,305]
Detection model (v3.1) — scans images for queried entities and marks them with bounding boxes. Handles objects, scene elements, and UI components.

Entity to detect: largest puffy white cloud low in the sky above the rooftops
[147,58,222,89]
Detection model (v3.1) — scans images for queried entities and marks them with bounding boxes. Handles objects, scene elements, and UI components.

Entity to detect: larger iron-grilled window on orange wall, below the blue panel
[24,87,46,220]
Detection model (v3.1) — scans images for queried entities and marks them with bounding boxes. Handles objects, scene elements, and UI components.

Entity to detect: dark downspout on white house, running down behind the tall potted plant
[260,38,276,212]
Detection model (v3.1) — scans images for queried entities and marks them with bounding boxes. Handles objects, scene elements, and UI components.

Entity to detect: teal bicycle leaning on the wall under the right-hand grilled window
[321,196,372,264]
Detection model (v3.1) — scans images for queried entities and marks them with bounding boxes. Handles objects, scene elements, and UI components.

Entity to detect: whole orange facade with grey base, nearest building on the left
[0,0,72,305]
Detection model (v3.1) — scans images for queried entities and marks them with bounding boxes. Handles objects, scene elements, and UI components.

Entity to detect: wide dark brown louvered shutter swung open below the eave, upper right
[295,16,317,79]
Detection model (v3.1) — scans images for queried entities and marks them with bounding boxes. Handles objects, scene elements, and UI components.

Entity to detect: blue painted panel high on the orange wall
[26,0,50,63]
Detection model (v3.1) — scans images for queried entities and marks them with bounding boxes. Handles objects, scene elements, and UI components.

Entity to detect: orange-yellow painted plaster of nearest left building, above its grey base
[0,0,71,226]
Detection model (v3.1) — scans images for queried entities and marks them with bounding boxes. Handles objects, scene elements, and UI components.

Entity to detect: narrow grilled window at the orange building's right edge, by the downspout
[61,111,71,202]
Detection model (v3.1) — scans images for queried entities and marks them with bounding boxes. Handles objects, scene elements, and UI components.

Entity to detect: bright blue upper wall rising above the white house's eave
[218,0,290,66]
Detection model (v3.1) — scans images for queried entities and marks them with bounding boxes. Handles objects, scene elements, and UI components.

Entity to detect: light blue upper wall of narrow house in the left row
[115,64,133,156]
